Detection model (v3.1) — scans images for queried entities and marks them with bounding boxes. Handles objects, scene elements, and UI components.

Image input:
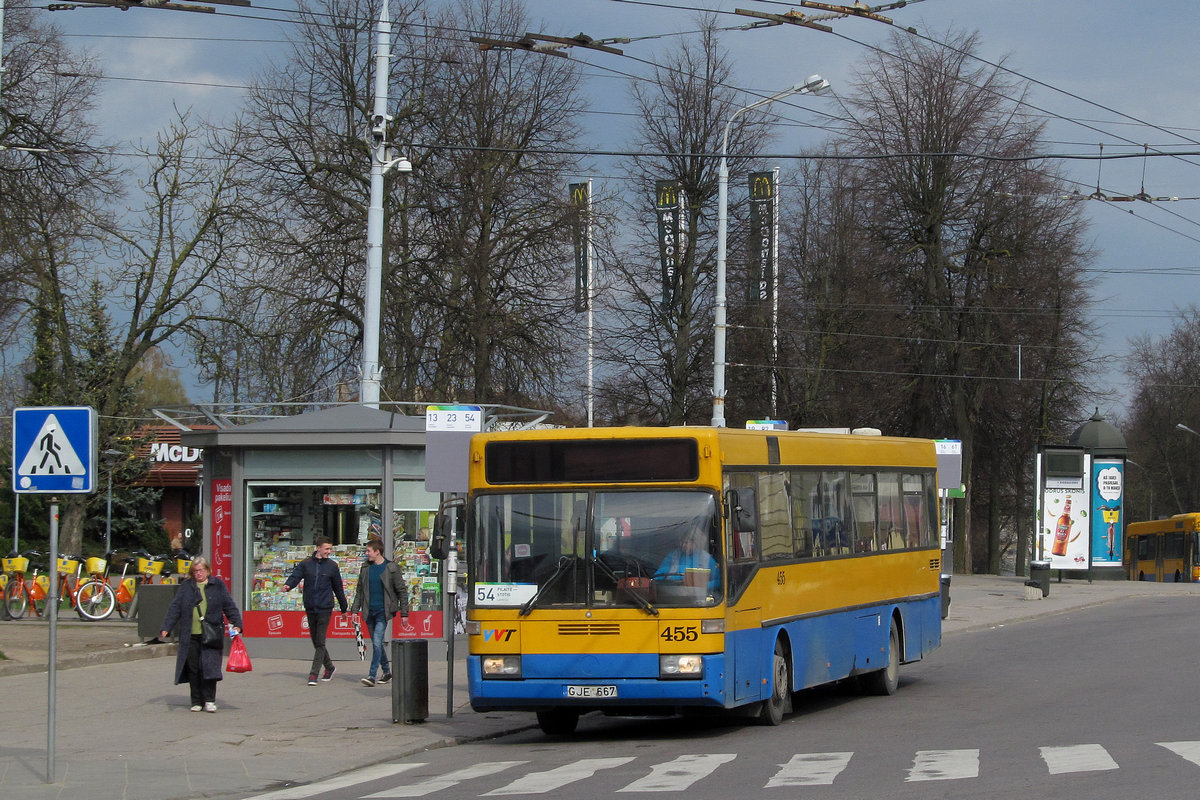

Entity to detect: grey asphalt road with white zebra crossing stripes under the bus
[248,596,1200,800]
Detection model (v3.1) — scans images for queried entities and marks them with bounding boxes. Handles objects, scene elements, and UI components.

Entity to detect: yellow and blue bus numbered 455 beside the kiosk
[466,427,942,734]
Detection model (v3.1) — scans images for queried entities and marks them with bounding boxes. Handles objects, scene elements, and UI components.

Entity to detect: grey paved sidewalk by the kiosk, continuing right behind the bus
[0,576,1200,800]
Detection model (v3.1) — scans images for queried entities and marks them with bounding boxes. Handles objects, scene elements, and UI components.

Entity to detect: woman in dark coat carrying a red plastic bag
[158,558,241,714]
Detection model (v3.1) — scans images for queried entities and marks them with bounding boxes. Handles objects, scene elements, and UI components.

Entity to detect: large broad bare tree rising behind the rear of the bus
[787,28,1090,570]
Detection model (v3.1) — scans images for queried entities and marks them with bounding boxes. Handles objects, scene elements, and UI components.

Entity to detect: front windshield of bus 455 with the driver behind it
[468,489,722,613]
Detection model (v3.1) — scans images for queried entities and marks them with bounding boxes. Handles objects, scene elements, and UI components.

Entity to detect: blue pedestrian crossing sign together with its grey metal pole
[12,405,98,783]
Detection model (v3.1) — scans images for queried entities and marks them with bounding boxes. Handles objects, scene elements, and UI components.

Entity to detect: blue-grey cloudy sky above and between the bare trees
[32,0,1200,415]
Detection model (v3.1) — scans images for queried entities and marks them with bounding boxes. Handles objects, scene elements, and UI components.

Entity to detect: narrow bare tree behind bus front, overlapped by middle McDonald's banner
[599,18,768,425]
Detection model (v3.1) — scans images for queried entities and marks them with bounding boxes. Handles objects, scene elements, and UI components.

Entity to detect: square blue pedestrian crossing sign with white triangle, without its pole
[12,405,98,494]
